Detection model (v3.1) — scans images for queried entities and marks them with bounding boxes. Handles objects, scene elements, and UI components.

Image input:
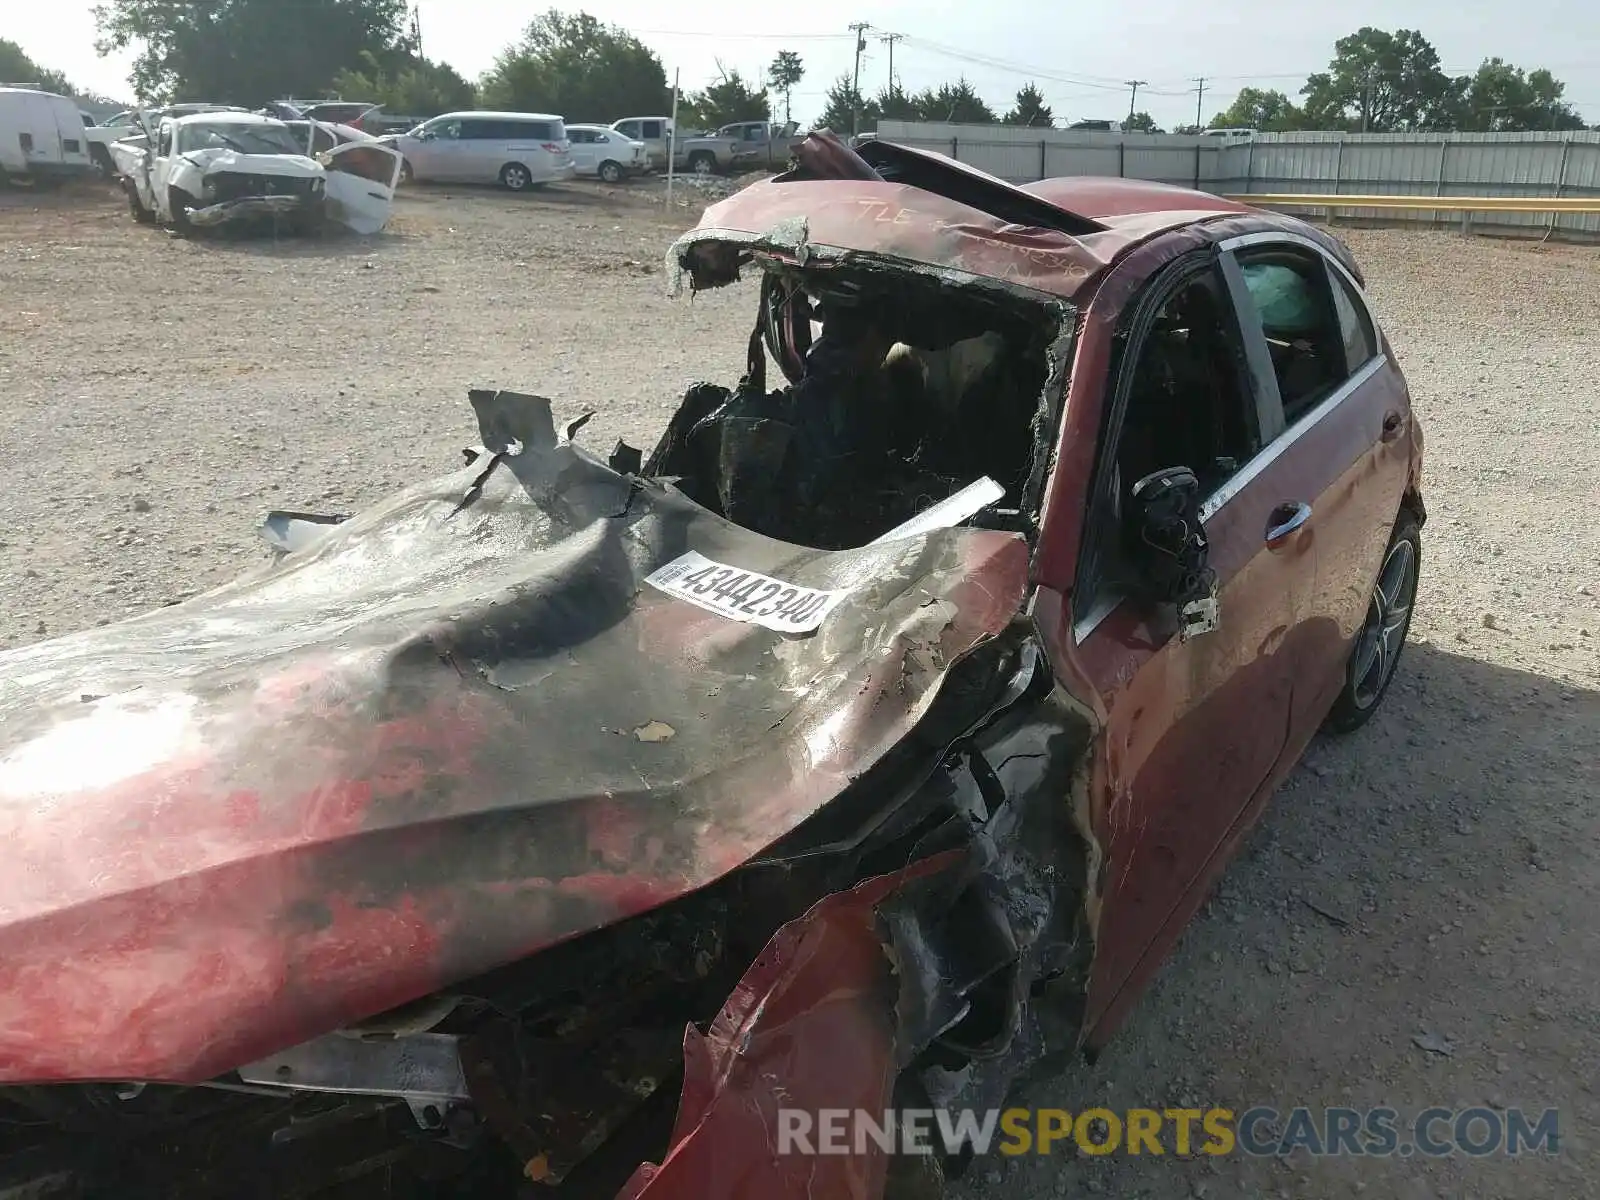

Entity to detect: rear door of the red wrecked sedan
[1222,232,1411,755]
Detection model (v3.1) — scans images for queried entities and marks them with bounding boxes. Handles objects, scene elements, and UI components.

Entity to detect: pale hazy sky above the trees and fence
[12,0,1600,128]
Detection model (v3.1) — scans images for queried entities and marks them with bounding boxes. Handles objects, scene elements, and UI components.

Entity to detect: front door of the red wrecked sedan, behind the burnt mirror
[1072,248,1317,1045]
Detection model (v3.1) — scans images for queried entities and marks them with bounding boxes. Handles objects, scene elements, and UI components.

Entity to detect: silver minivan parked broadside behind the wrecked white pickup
[381,112,578,192]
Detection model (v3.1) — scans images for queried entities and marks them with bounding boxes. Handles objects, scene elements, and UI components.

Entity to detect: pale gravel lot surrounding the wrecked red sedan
[0,187,1600,1200]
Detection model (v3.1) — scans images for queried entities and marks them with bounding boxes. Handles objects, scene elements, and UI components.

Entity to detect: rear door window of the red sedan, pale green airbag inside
[1238,251,1349,426]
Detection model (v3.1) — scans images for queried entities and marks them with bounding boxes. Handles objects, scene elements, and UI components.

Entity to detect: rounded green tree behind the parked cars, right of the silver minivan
[482,8,672,122]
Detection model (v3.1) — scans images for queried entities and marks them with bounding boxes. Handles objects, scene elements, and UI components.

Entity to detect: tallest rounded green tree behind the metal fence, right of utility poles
[1301,26,1467,133]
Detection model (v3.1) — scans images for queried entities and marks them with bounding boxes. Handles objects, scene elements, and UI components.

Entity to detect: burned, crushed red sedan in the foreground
[0,136,1424,1200]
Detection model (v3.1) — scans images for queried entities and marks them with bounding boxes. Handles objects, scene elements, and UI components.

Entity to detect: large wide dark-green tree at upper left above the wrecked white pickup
[94,0,406,104]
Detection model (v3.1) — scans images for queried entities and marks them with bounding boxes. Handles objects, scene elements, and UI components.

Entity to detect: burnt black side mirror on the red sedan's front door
[1126,467,1218,642]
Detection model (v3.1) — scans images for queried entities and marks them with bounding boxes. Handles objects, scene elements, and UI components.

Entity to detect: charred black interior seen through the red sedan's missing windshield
[643,256,1061,550]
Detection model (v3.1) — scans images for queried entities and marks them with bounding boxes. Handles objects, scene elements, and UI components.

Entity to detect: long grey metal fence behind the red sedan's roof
[878,122,1600,234]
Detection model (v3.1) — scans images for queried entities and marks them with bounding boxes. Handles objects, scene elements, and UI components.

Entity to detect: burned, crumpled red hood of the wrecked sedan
[0,394,1027,1082]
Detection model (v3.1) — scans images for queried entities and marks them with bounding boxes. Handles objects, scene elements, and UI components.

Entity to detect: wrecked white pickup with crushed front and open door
[110,112,400,234]
